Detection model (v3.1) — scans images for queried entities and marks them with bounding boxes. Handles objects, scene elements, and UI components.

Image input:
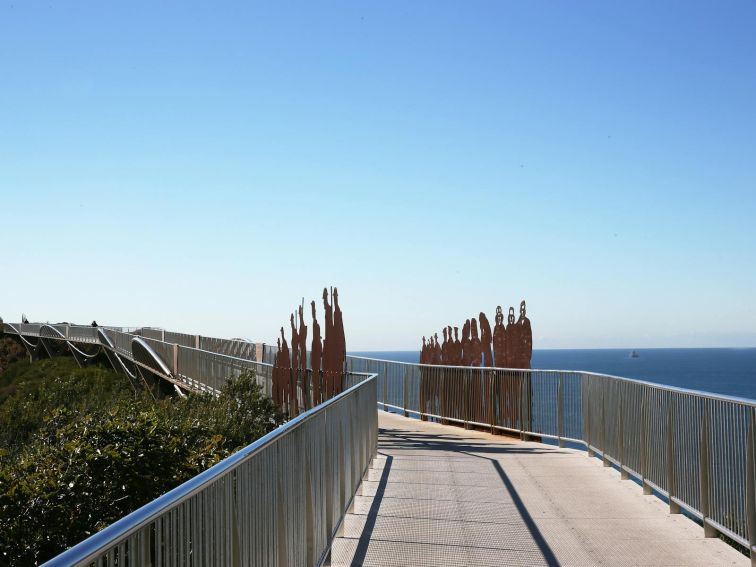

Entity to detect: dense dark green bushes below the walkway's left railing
[0,357,284,565]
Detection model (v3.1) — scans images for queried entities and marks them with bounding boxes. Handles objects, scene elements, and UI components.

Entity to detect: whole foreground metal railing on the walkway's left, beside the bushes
[41,376,378,567]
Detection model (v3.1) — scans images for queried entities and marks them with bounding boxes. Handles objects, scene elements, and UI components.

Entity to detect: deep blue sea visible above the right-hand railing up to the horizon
[350,348,756,400]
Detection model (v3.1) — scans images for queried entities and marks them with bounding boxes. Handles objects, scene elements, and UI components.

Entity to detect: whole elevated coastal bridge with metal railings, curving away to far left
[4,324,756,566]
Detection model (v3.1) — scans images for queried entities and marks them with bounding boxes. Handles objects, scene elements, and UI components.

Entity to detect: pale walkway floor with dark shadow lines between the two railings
[332,411,750,567]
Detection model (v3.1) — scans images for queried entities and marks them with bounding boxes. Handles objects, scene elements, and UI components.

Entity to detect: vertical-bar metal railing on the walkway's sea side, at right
[347,356,756,558]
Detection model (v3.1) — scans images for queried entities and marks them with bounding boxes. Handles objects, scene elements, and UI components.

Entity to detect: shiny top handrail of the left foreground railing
[44,374,376,567]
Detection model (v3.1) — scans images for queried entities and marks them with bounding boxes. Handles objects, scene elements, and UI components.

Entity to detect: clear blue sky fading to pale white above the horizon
[0,0,756,350]
